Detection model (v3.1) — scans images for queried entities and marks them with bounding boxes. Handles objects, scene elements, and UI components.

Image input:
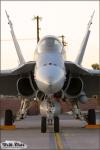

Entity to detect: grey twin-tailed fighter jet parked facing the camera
[0,12,100,133]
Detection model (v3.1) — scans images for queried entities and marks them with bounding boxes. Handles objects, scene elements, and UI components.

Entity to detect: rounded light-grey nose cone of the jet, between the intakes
[36,66,65,94]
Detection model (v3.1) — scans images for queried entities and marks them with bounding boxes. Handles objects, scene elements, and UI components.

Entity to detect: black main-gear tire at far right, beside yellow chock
[87,109,96,125]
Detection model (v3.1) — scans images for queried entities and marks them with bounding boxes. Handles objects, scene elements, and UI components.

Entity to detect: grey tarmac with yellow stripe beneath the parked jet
[1,115,100,150]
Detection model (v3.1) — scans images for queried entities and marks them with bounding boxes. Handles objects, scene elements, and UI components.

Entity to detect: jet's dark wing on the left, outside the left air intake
[0,62,35,96]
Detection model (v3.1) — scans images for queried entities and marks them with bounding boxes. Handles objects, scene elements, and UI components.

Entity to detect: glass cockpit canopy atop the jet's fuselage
[38,36,62,53]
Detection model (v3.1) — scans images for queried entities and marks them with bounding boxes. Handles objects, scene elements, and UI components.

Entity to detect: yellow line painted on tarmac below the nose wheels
[54,133,64,150]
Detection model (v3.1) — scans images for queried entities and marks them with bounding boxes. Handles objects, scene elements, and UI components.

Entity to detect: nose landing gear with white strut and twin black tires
[40,100,61,133]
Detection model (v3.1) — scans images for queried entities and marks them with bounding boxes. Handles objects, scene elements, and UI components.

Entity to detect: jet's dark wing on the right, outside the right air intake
[65,61,100,97]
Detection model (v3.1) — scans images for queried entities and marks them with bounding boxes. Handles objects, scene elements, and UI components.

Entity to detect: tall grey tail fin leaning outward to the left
[5,10,25,64]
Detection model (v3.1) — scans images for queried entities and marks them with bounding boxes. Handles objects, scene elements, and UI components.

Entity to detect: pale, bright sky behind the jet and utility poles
[1,1,100,70]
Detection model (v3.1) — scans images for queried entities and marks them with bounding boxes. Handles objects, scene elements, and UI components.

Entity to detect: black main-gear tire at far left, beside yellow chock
[5,109,14,125]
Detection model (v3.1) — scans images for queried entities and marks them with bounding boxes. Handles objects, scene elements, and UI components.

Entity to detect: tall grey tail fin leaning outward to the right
[75,11,95,65]
